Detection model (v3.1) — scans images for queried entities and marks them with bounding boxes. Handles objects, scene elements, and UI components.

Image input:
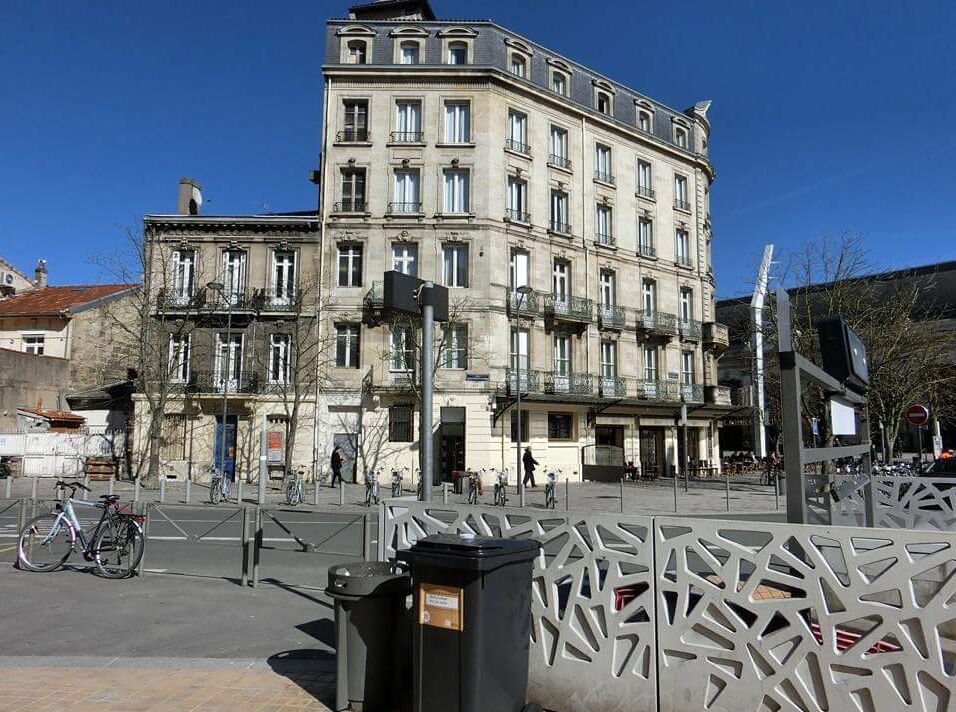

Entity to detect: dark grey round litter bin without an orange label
[325,561,411,712]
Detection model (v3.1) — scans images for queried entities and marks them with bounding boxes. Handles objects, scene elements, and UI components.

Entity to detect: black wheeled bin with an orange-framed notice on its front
[397,534,540,712]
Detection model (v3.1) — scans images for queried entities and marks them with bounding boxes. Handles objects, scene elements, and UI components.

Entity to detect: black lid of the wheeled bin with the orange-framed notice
[395,534,541,571]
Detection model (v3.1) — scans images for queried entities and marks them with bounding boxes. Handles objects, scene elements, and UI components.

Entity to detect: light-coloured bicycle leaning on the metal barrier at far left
[17,480,146,579]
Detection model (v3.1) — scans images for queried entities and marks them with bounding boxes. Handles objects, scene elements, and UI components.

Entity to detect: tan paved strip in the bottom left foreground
[0,658,335,712]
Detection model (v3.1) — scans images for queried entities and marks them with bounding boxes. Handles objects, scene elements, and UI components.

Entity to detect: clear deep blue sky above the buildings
[0,0,956,296]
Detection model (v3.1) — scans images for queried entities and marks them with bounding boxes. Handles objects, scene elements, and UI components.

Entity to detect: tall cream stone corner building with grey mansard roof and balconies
[318,1,729,481]
